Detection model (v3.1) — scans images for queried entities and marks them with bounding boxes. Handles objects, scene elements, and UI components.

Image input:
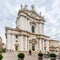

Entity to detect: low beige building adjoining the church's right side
[49,39,60,54]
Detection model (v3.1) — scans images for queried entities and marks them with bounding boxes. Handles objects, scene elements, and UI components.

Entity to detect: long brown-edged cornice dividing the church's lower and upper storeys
[6,27,50,38]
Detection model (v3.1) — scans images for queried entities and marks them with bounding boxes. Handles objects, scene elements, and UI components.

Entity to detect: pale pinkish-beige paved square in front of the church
[2,52,60,60]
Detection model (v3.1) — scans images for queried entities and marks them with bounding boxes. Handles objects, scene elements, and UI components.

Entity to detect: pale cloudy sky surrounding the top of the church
[0,0,60,43]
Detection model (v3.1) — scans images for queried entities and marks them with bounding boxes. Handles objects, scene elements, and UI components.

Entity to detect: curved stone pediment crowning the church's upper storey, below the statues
[18,9,45,21]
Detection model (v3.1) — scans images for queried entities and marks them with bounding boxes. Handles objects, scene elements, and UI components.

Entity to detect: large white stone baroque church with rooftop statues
[5,5,50,52]
